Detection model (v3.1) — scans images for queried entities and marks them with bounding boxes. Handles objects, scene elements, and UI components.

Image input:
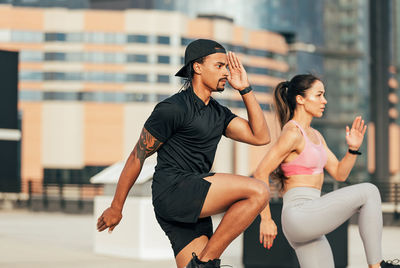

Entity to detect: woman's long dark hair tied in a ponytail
[271,74,321,189]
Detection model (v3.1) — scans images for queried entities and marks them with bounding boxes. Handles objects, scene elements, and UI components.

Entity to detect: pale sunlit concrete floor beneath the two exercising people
[0,210,400,268]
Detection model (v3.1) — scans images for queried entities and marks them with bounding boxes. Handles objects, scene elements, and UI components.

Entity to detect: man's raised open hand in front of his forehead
[227,51,250,91]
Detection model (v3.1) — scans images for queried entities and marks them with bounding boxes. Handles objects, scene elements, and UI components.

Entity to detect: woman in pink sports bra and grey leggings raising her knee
[254,74,400,268]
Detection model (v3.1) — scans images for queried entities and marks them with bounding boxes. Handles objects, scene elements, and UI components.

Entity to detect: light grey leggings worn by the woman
[282,183,382,268]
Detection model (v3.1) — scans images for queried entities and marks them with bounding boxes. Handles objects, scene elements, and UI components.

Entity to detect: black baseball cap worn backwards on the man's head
[175,39,226,77]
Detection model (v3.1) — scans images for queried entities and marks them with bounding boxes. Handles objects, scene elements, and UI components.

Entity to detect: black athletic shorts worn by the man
[153,173,214,256]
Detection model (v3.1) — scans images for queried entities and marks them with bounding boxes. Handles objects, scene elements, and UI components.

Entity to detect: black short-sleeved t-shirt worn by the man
[144,88,236,199]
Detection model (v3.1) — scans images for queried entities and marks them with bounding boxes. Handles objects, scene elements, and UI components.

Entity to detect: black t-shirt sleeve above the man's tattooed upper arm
[144,101,185,142]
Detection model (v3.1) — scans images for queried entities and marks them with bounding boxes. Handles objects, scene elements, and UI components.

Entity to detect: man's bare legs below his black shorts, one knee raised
[176,173,269,267]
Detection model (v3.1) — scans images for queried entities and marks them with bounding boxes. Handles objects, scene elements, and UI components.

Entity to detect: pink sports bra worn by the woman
[281,120,328,177]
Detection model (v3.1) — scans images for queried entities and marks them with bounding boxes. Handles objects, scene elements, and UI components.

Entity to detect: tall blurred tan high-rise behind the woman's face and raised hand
[316,0,371,182]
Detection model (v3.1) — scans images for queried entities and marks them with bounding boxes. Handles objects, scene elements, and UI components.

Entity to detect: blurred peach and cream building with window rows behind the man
[0,1,289,189]
